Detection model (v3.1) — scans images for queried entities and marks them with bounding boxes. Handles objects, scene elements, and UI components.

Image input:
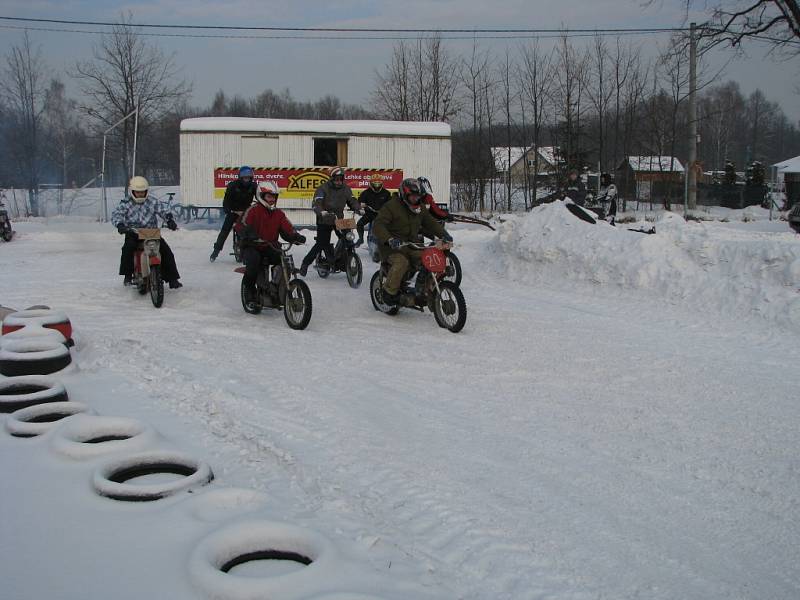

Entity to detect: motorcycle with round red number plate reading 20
[369,242,467,333]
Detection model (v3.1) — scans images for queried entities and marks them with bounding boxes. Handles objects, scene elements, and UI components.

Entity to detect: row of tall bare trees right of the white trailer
[371,33,800,210]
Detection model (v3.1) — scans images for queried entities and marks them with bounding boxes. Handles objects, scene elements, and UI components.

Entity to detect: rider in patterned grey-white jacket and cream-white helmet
[111,175,183,290]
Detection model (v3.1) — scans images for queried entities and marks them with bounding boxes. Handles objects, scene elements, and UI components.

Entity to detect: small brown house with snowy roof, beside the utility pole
[616,156,684,203]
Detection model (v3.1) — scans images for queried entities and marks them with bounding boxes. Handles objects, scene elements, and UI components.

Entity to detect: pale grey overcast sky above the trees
[0,0,800,121]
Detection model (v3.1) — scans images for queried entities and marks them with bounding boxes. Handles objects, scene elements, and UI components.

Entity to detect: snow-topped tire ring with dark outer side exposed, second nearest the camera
[92,452,214,502]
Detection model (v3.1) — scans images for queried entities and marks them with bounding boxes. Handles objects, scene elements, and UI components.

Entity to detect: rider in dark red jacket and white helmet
[240,181,306,302]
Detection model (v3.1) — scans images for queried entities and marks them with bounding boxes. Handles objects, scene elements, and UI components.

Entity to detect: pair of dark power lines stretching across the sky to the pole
[0,16,689,33]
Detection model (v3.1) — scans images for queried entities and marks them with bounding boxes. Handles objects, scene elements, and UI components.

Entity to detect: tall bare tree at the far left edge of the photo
[2,32,47,216]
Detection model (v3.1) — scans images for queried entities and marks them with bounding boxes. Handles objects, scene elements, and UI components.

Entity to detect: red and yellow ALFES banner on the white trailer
[214,167,403,202]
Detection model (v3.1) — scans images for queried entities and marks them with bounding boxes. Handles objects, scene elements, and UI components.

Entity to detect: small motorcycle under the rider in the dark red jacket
[235,240,312,329]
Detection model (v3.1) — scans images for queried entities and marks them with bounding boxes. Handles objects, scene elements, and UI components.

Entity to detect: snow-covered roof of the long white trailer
[181,117,450,138]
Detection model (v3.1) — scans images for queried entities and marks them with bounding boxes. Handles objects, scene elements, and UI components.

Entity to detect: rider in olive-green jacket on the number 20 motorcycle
[372,178,453,304]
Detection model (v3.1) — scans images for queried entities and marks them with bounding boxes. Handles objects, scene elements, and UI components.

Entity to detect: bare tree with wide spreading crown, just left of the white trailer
[75,14,191,183]
